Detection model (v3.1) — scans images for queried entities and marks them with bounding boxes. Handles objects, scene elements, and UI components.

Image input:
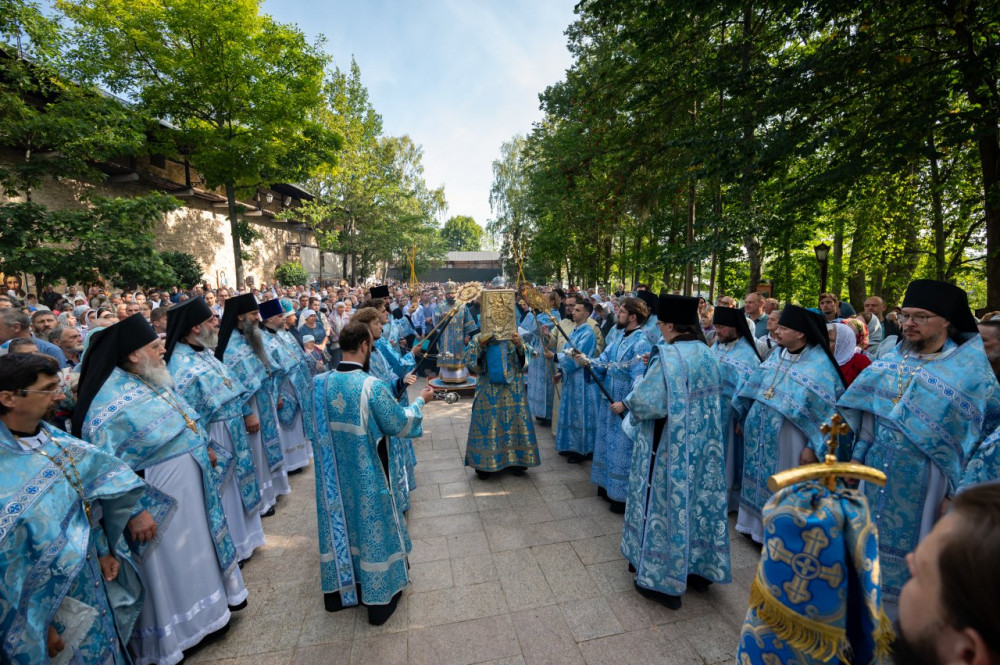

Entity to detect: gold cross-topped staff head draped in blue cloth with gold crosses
[737,415,893,665]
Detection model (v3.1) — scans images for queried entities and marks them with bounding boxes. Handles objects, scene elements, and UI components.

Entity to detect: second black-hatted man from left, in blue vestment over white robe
[163,297,264,561]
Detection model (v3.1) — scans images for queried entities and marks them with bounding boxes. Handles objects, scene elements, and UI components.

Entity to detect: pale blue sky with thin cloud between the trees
[264,0,575,231]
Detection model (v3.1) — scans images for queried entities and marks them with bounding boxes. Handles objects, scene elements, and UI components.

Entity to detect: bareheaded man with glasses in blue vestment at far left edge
[0,354,146,665]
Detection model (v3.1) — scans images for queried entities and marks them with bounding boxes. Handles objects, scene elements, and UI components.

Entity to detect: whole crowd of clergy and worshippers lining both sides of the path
[0,272,1000,665]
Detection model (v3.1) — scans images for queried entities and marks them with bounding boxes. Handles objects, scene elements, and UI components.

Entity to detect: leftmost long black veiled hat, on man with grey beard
[73,314,159,438]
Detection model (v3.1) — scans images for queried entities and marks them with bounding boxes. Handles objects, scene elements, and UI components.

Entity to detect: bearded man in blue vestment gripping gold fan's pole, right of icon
[576,298,650,514]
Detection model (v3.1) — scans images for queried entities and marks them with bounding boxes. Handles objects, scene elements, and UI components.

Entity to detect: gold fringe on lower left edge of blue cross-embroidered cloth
[750,576,848,663]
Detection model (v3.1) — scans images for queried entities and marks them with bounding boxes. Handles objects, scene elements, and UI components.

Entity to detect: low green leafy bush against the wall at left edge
[0,194,179,287]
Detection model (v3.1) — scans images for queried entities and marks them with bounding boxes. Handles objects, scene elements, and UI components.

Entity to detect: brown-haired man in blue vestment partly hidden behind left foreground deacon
[351,303,417,513]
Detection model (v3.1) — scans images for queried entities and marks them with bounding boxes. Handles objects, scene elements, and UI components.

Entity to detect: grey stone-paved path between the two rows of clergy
[186,386,759,665]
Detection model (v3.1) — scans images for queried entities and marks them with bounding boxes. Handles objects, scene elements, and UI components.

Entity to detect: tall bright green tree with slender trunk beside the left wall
[63,0,341,284]
